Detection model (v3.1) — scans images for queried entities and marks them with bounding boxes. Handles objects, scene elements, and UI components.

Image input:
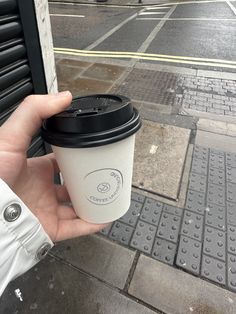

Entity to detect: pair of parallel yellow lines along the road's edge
[54,48,236,69]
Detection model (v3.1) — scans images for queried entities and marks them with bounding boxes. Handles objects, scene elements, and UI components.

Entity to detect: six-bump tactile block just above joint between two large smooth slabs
[130,221,157,254]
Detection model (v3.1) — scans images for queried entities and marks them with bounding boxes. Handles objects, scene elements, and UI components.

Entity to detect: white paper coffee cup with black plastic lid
[42,95,141,223]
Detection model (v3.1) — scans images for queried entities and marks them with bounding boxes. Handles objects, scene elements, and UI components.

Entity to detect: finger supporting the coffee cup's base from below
[55,218,109,241]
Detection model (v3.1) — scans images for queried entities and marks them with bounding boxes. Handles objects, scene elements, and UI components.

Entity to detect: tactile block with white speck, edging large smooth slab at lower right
[176,235,202,275]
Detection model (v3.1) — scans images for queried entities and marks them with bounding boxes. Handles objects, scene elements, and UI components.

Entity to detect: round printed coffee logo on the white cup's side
[84,168,123,205]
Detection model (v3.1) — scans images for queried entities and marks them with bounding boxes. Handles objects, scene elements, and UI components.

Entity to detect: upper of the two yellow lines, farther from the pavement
[54,48,236,65]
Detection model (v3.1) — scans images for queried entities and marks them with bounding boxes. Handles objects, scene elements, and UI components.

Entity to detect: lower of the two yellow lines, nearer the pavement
[54,49,236,69]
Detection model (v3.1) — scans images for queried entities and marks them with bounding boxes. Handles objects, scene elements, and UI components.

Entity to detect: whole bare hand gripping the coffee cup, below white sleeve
[0,92,106,242]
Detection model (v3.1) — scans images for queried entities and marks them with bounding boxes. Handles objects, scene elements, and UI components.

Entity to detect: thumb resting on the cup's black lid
[1,92,72,152]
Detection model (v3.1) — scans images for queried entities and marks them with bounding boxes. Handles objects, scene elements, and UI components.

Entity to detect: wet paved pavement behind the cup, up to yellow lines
[0,54,236,314]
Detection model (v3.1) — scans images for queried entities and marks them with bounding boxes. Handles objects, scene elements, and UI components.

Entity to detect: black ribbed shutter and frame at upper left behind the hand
[0,0,47,157]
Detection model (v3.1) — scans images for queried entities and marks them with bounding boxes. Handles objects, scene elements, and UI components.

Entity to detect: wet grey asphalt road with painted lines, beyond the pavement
[50,0,236,72]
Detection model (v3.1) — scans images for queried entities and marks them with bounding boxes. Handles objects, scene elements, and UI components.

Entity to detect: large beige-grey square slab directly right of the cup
[133,121,190,199]
